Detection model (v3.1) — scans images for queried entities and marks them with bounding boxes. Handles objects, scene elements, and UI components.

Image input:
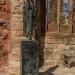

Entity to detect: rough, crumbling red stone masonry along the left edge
[0,0,11,74]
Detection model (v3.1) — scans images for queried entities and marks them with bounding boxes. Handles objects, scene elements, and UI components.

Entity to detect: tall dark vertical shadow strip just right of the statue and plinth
[39,0,46,67]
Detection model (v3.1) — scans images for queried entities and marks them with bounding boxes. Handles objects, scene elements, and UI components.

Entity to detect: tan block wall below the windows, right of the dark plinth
[40,32,75,71]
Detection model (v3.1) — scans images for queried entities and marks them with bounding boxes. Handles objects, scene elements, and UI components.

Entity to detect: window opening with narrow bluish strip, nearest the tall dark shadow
[46,0,58,32]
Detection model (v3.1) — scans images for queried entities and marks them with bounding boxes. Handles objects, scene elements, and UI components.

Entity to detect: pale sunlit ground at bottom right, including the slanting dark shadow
[39,65,75,75]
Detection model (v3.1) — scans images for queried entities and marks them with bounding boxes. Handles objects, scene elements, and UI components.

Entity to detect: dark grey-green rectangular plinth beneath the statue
[22,40,39,75]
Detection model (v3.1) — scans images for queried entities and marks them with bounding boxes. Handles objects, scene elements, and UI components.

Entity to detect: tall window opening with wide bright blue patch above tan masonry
[59,0,70,33]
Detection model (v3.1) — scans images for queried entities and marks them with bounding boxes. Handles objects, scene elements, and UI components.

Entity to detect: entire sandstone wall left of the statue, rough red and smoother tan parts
[0,0,23,75]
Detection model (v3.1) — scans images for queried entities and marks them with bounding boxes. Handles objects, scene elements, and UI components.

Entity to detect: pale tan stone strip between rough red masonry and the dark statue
[7,0,24,75]
